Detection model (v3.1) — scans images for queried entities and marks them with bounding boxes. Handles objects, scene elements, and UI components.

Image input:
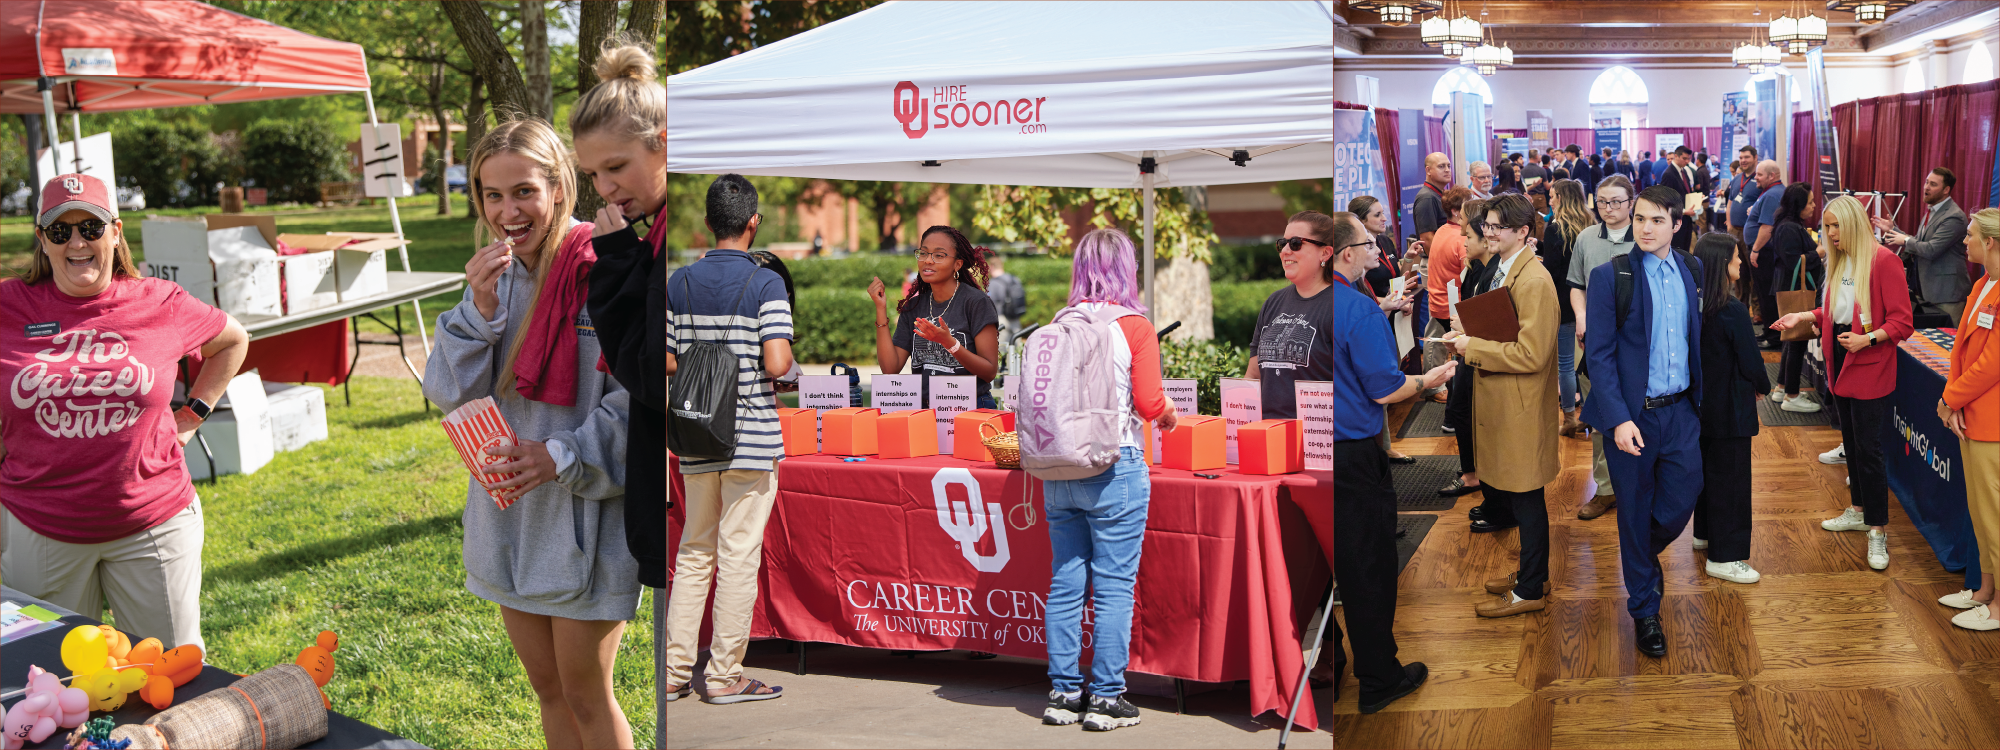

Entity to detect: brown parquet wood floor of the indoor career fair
[1334,356,2000,748]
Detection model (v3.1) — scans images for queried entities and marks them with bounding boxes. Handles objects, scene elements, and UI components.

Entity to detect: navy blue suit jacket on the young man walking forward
[1582,248,1702,434]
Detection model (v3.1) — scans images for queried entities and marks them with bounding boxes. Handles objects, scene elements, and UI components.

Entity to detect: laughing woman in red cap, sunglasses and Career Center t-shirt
[0,174,250,648]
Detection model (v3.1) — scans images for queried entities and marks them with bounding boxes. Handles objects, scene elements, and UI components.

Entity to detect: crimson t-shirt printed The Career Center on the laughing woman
[0,278,228,544]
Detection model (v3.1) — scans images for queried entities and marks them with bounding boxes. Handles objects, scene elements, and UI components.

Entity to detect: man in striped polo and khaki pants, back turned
[666,174,792,702]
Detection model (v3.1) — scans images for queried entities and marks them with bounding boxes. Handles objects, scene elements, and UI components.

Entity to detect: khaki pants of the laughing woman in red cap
[0,498,206,650]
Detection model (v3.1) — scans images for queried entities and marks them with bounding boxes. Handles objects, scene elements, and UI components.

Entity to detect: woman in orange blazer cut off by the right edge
[1938,208,2000,630]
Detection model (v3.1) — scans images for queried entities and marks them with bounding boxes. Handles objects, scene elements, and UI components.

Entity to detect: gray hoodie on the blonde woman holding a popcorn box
[424,254,640,620]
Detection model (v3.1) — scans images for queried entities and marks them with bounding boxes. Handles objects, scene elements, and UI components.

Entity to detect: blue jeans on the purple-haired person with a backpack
[1042,448,1152,698]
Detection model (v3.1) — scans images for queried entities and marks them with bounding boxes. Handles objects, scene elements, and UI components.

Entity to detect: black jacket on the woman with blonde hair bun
[588,218,666,588]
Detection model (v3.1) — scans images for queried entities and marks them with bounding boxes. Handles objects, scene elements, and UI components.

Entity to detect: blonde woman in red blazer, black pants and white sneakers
[1772,196,1916,570]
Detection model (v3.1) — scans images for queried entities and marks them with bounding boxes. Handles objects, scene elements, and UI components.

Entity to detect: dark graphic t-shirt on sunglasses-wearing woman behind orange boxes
[1250,286,1334,420]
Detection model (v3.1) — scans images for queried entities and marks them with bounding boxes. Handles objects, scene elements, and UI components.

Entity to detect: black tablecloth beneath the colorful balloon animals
[0,586,424,750]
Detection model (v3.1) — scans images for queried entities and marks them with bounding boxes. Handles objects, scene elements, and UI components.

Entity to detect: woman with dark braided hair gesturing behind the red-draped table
[868,224,1000,408]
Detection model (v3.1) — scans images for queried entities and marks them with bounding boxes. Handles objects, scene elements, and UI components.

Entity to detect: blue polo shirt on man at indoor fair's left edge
[1334,272,1408,440]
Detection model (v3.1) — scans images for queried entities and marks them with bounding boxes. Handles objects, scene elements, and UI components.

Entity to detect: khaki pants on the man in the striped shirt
[666,464,778,692]
